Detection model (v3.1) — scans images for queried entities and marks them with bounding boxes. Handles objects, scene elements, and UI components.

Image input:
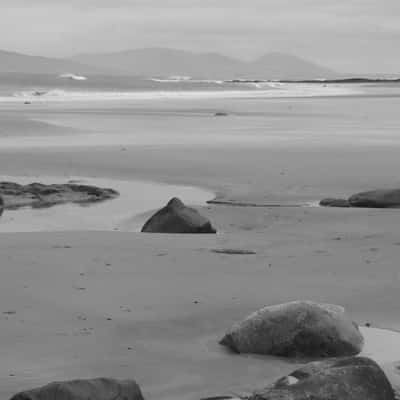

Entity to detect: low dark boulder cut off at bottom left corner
[11,378,143,400]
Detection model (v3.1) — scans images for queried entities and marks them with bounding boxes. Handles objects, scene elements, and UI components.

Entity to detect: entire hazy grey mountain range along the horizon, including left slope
[0,48,342,80]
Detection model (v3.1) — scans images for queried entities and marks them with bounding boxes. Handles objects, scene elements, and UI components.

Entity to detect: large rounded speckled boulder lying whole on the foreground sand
[220,301,364,357]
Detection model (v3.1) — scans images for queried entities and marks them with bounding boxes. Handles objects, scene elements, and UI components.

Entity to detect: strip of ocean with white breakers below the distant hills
[0,73,382,102]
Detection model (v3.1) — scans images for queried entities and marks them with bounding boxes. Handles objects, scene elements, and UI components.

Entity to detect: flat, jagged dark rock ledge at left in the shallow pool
[0,182,119,209]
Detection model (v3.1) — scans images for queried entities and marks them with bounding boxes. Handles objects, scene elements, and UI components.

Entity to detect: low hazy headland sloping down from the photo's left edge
[0,50,101,74]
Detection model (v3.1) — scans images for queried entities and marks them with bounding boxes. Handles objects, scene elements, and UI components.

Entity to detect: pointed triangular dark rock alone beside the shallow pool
[142,197,216,233]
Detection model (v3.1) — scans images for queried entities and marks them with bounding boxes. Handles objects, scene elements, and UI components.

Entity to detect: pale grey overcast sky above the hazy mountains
[0,0,400,73]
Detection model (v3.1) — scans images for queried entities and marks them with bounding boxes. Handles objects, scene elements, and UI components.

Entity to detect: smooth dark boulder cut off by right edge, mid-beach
[349,189,400,208]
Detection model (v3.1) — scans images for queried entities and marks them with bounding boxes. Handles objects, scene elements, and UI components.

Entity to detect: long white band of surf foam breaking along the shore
[0,82,362,102]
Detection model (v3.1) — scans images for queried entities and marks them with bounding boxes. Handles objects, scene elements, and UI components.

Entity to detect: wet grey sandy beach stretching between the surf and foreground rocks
[0,89,400,400]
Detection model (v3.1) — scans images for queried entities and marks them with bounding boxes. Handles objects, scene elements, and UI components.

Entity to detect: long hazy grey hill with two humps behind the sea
[72,48,338,79]
